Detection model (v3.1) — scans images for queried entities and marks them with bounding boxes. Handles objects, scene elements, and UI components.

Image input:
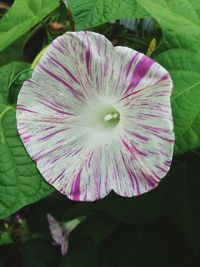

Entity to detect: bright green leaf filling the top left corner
[0,0,59,51]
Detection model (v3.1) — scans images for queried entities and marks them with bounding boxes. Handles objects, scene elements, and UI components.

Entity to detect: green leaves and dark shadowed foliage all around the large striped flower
[0,0,200,267]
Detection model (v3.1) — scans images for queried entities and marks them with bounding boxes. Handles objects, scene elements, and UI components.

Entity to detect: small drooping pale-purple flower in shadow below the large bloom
[47,213,81,255]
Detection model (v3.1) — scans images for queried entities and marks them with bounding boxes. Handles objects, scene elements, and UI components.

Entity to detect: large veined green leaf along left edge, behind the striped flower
[0,63,53,218]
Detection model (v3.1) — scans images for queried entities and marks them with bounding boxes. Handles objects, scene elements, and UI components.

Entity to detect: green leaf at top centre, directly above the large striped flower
[68,0,148,31]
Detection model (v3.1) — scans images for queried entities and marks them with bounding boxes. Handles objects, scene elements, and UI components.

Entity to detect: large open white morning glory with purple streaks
[17,32,174,201]
